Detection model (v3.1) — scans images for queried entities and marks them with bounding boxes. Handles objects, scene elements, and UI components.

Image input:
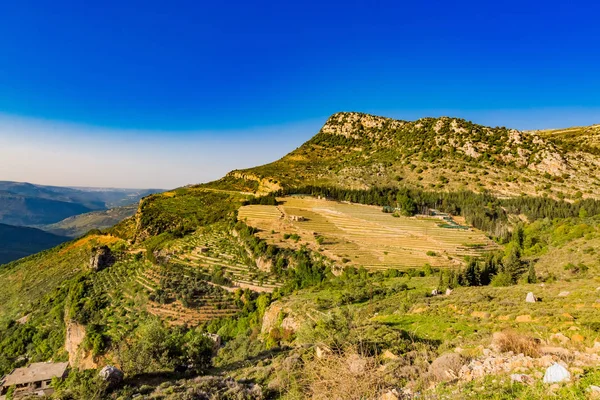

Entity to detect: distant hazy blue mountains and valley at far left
[0,181,162,264]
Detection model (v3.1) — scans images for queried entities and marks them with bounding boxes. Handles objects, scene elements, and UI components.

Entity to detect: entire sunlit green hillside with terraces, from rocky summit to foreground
[0,113,600,400]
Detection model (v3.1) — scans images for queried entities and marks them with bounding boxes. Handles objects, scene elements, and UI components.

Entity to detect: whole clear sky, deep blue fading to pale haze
[0,0,600,187]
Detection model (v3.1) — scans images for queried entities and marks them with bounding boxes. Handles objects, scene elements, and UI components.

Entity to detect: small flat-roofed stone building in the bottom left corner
[0,362,69,398]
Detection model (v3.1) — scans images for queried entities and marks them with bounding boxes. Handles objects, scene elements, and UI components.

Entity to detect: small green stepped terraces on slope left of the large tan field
[163,228,282,292]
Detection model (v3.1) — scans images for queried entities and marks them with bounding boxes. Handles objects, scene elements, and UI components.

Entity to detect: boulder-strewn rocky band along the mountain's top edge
[319,112,570,175]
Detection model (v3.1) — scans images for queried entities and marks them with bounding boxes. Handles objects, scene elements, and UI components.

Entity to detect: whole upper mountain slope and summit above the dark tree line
[226,112,600,198]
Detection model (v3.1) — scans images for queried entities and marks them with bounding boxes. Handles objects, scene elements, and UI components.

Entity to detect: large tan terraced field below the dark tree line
[238,196,496,269]
